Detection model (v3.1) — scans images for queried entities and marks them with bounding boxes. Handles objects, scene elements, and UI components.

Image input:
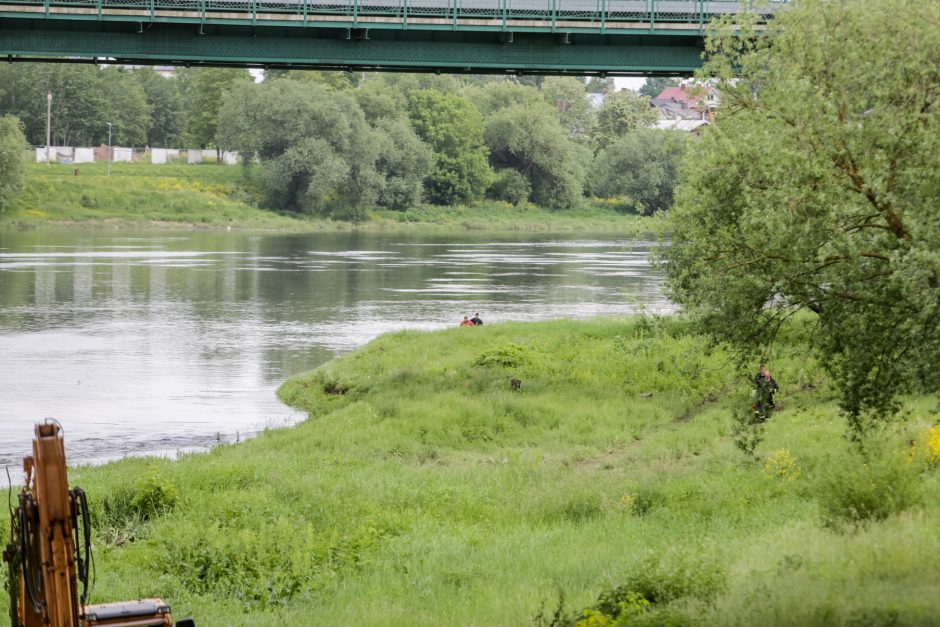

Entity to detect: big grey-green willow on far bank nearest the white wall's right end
[218,80,382,219]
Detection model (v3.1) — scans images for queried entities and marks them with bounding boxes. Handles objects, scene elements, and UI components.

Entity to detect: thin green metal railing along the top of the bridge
[0,0,787,29]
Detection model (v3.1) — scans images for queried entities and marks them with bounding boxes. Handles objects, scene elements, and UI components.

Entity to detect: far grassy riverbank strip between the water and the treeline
[0,163,664,235]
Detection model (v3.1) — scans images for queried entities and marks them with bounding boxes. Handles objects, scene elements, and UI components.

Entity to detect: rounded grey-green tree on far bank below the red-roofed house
[593,129,688,215]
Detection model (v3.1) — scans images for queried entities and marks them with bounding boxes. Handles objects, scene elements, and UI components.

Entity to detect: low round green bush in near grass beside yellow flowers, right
[816,452,922,530]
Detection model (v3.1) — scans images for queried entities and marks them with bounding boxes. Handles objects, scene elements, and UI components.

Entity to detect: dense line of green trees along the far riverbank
[0,64,682,219]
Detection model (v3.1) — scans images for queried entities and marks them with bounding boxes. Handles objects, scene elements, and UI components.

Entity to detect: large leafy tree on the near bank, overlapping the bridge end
[662,0,940,435]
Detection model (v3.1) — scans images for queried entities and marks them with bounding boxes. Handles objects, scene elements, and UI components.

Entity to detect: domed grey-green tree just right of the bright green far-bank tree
[485,103,589,208]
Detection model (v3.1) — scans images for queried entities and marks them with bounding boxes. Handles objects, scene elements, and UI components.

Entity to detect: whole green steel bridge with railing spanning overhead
[0,0,785,76]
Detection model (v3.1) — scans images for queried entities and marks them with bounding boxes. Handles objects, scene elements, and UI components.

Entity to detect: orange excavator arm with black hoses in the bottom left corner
[3,420,195,627]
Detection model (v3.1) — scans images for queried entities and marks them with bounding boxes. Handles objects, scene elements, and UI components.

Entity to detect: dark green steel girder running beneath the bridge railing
[0,18,702,76]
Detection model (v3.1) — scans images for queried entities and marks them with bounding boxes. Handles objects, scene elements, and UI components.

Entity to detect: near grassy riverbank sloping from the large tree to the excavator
[0,318,940,626]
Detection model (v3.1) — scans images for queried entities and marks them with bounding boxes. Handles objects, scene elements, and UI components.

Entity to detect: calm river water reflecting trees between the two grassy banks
[0,230,670,470]
